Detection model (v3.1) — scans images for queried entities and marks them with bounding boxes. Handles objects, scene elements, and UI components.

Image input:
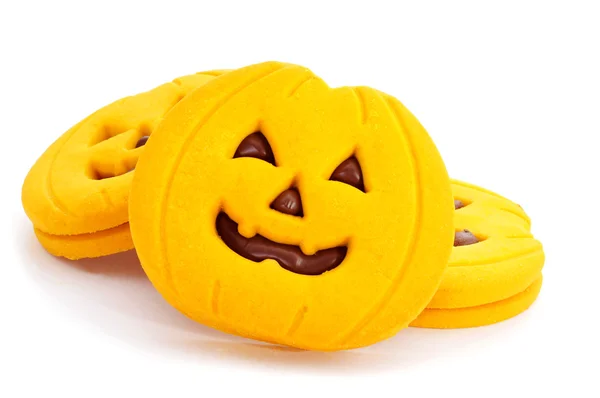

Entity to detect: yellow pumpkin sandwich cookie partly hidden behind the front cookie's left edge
[22,71,223,259]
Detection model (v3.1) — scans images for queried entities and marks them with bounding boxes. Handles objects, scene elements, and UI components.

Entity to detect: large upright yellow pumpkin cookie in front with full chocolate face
[129,62,454,350]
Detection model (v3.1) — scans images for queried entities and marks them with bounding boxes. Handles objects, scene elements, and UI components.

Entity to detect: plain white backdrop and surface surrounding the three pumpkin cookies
[0,0,600,397]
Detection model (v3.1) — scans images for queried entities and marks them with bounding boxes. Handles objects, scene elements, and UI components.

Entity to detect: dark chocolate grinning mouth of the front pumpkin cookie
[216,212,348,275]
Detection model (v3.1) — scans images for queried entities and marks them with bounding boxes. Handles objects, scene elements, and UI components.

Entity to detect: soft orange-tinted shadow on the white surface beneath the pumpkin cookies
[13,215,528,374]
